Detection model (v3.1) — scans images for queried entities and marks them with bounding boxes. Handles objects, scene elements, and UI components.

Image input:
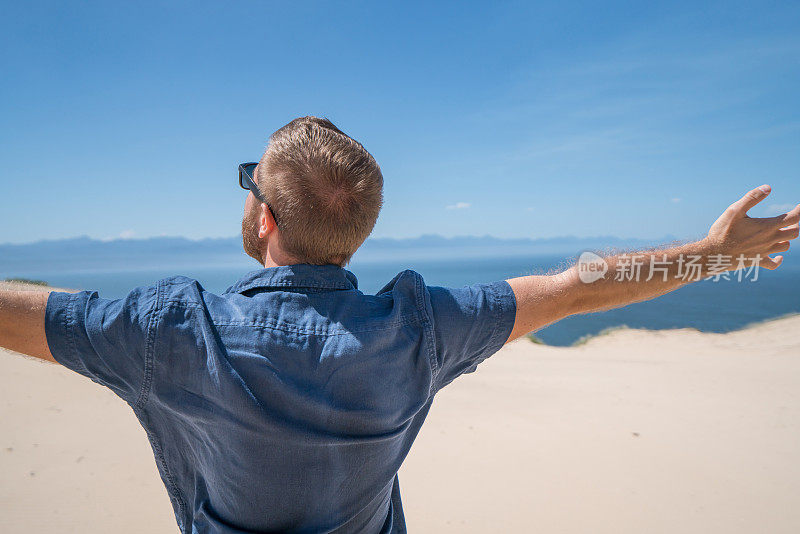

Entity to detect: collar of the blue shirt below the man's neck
[225,263,358,293]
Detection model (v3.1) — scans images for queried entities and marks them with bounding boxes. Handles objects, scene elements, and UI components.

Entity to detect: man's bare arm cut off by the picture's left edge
[0,289,55,362]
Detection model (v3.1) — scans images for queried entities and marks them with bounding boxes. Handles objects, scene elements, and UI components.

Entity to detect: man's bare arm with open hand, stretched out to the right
[507,185,800,341]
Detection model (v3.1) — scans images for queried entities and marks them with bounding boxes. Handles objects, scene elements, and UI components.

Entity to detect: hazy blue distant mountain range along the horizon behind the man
[0,234,675,276]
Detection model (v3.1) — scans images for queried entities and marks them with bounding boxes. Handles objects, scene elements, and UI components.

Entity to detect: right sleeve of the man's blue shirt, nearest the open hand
[428,280,517,390]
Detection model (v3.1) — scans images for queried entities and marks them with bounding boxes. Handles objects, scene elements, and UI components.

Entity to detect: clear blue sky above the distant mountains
[0,2,800,242]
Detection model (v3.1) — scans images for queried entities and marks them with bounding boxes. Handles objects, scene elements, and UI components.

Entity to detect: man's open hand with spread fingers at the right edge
[705,185,800,270]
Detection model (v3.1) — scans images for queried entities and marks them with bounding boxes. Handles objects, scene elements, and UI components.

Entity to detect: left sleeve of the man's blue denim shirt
[45,286,157,404]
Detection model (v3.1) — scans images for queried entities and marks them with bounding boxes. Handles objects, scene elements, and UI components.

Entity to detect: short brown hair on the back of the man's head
[257,117,383,266]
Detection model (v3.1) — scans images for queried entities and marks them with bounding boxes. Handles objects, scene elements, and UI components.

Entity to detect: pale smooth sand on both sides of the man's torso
[0,282,800,534]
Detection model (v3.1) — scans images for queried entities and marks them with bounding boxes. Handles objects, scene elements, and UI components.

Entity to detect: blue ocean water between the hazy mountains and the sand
[7,254,800,346]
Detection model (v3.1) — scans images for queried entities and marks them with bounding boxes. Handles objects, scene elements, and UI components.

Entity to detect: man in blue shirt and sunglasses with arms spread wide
[0,117,800,533]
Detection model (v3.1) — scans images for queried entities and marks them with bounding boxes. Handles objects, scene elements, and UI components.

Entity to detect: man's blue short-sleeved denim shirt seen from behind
[45,264,516,533]
